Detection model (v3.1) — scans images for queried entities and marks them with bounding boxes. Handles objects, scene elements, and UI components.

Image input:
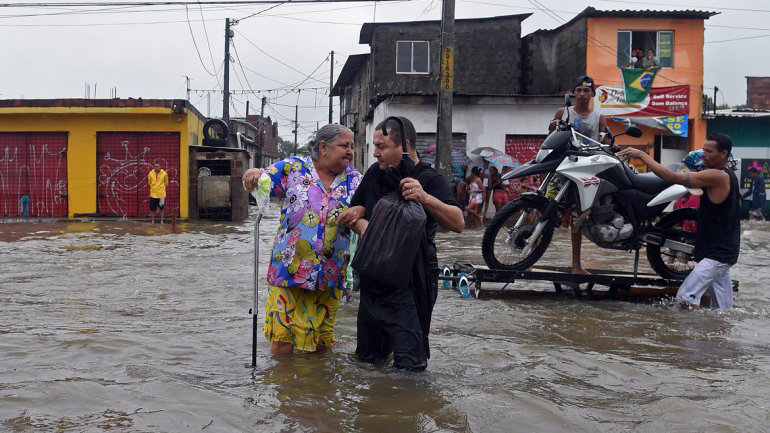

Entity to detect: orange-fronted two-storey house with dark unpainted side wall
[523,7,716,167]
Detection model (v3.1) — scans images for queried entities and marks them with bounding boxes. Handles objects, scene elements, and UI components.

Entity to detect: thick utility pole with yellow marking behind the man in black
[436,0,455,180]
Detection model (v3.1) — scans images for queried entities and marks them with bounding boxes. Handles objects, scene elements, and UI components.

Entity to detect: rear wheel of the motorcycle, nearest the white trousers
[647,208,698,280]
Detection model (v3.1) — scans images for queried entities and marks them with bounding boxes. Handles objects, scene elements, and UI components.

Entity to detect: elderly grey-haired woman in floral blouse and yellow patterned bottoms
[243,124,361,354]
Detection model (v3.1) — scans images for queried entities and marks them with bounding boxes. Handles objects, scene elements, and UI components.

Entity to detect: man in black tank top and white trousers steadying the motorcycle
[617,134,741,309]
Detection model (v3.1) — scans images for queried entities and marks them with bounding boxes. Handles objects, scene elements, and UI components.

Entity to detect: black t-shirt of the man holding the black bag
[350,162,460,269]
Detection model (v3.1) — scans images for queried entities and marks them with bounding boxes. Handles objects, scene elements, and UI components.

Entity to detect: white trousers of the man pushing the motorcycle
[676,259,733,309]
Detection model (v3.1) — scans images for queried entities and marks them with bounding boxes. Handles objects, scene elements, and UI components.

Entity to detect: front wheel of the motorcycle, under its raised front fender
[481,199,554,271]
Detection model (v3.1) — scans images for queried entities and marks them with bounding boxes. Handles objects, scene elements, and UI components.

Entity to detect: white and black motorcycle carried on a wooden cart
[482,97,697,280]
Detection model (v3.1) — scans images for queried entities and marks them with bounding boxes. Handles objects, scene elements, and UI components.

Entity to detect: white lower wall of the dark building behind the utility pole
[365,97,561,167]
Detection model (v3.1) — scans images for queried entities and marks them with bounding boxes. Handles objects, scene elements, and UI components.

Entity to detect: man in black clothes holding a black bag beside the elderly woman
[338,117,465,371]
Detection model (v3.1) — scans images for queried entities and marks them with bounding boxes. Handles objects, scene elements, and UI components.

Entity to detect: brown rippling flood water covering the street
[0,212,770,432]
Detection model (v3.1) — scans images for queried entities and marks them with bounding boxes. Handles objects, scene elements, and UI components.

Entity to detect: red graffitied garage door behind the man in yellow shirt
[96,132,179,218]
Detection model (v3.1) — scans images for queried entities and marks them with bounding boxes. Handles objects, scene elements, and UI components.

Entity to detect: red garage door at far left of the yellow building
[0,132,68,217]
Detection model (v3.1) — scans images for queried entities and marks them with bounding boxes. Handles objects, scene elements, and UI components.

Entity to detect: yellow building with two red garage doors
[0,99,205,218]
